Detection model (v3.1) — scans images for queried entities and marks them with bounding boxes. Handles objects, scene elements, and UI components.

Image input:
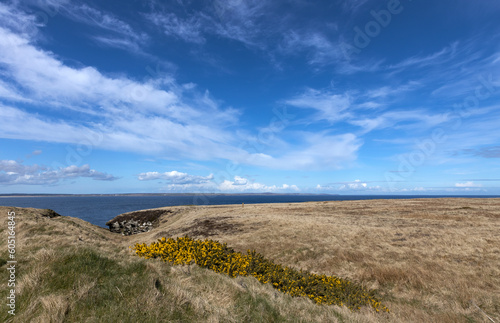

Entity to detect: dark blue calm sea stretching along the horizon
[0,195,498,227]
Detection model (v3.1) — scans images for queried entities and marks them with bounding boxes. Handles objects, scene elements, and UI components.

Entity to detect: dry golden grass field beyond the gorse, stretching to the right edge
[125,199,500,322]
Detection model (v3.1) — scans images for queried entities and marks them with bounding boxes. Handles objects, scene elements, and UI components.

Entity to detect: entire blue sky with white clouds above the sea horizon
[0,0,500,195]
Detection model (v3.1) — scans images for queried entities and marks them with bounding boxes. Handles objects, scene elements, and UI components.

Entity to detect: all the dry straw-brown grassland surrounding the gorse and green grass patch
[0,199,500,322]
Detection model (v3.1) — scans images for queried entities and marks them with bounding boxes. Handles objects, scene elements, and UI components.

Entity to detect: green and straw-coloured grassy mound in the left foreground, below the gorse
[0,247,352,322]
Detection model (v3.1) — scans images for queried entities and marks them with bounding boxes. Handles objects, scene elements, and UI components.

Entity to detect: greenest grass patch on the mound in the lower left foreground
[0,248,201,322]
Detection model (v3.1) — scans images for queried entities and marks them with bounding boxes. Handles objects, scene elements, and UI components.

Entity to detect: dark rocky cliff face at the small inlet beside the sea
[106,210,172,236]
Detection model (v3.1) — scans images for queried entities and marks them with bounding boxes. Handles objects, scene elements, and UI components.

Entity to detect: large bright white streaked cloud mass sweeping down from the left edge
[0,22,242,157]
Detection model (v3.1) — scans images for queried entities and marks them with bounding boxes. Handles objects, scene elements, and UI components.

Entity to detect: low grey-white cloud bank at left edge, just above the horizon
[0,160,118,185]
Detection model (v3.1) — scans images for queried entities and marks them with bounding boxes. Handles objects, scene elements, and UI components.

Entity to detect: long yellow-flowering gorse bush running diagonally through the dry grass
[131,236,389,312]
